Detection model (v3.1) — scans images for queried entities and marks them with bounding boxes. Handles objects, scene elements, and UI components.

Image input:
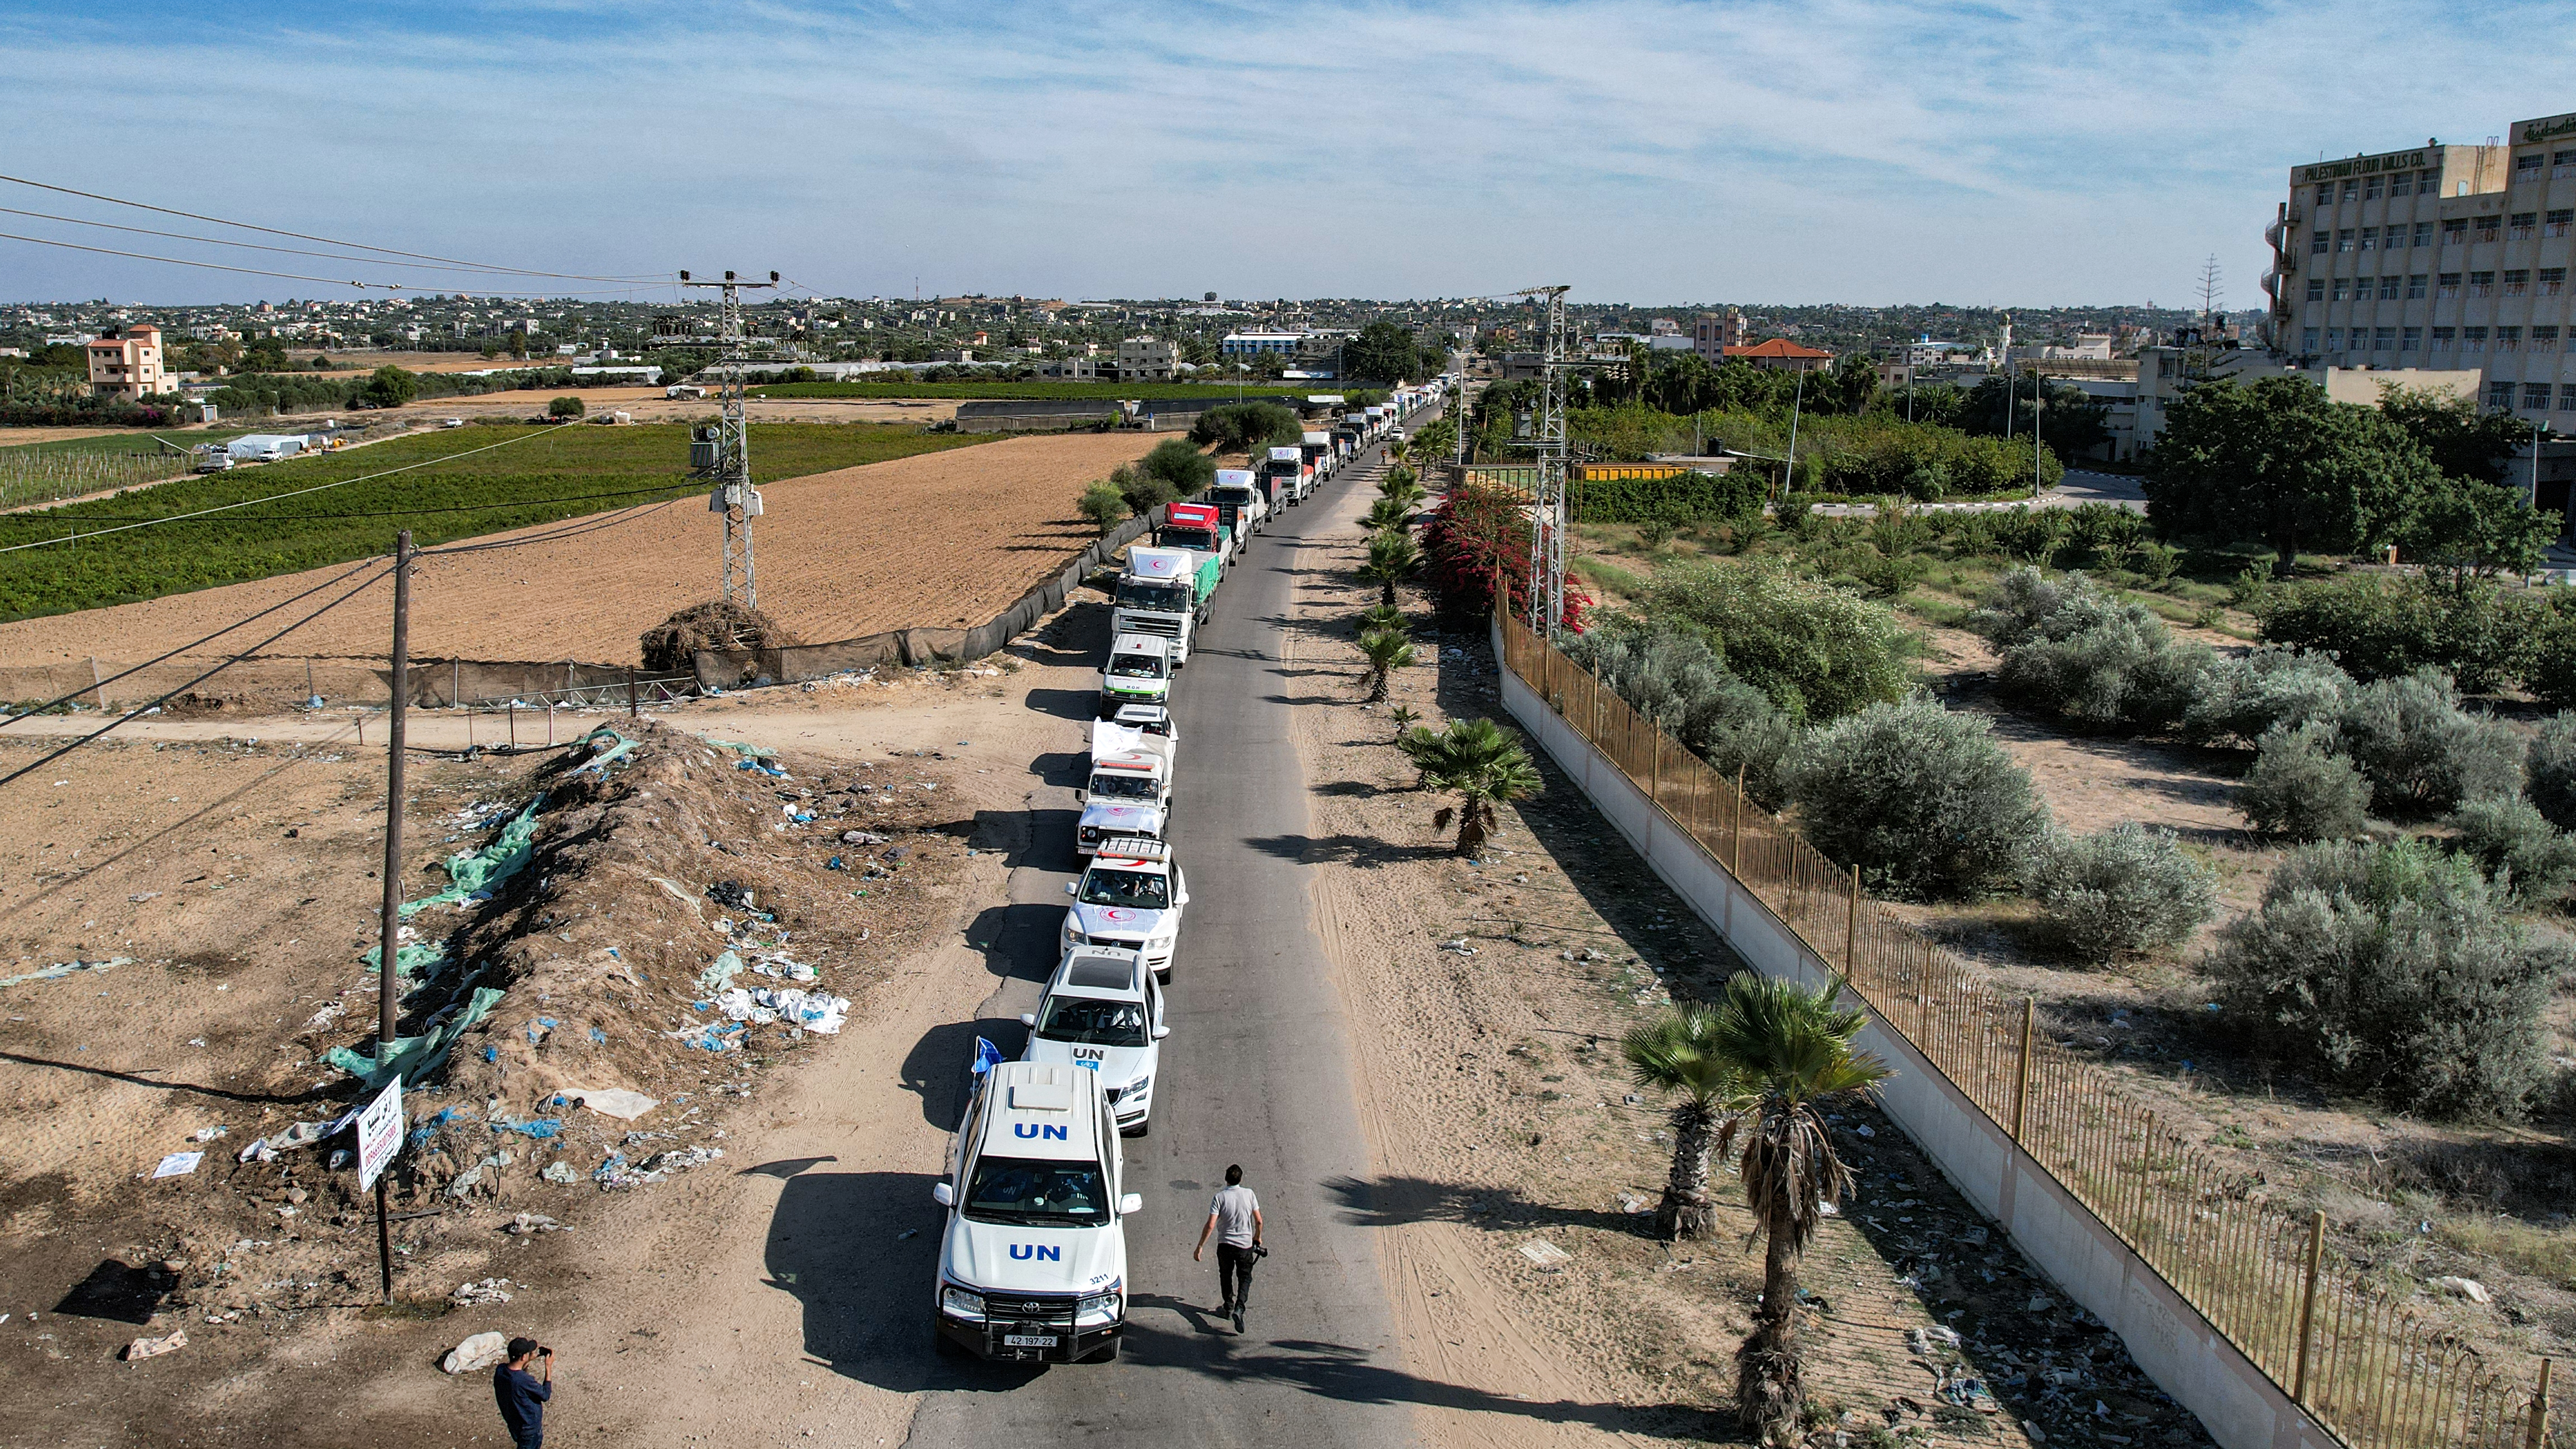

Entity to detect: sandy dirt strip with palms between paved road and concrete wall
[1293,510,2205,1449]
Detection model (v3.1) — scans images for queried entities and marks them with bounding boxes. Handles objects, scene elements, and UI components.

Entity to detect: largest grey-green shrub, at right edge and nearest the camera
[2210,841,2568,1116]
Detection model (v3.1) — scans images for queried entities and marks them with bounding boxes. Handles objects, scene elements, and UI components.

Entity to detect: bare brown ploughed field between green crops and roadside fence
[0,433,1157,665]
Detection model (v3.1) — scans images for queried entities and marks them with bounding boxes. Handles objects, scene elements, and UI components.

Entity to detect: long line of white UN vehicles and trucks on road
[930,381,1427,1364]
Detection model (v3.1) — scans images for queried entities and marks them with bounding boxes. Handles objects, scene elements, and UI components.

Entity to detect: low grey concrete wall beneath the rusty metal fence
[1494,624,2336,1449]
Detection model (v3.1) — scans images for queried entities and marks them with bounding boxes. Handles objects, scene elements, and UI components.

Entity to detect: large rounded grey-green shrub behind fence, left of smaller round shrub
[1785,693,2048,895]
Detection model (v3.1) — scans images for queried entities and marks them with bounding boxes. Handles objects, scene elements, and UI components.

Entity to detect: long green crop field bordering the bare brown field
[0,423,992,619]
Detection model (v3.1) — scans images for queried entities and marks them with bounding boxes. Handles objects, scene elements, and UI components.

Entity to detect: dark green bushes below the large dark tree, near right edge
[2251,575,2553,693]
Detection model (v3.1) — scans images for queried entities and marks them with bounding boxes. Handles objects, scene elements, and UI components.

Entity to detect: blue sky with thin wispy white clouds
[0,0,2576,307]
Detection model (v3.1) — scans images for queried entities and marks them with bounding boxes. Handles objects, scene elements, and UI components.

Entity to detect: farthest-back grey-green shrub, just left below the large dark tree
[1971,567,2215,730]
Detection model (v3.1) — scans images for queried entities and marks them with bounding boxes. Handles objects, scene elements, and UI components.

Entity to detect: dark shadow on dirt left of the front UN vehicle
[762,1160,1036,1395]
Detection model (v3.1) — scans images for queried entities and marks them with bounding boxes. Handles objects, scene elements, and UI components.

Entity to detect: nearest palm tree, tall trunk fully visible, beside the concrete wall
[1708,972,1888,1434]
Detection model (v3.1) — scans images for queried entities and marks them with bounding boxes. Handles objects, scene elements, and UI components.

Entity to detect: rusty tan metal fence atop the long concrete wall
[1502,608,2550,1449]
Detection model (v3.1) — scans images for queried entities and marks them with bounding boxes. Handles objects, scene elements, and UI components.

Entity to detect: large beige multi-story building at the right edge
[2264,113,2576,417]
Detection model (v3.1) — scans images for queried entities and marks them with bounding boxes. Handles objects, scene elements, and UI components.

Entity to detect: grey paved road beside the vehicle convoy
[889,412,1419,1449]
